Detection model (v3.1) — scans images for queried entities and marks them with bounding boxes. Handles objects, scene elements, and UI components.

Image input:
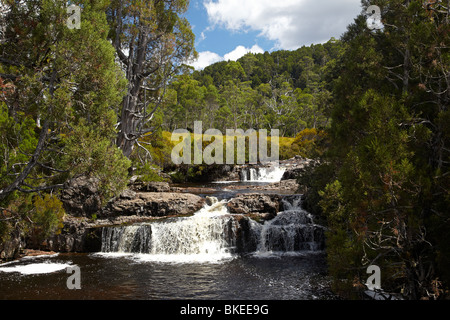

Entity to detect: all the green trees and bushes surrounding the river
[0,0,450,299]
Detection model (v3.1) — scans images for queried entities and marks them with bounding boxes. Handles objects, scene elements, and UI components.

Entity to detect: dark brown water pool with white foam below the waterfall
[0,252,334,300]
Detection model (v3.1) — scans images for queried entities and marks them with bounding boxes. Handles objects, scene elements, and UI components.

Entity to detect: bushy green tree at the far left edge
[0,0,130,239]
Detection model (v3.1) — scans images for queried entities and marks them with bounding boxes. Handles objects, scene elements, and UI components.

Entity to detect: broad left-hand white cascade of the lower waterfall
[102,201,236,262]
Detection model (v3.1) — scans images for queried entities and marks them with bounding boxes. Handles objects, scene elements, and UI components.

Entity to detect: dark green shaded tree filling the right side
[321,0,450,299]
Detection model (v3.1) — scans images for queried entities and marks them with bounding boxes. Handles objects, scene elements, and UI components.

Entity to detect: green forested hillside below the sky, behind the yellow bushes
[161,39,342,137]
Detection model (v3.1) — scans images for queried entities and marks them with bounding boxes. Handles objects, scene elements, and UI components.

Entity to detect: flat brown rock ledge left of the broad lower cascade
[27,190,206,252]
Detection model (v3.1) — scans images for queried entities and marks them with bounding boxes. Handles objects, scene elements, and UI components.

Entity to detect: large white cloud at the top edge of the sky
[204,0,361,50]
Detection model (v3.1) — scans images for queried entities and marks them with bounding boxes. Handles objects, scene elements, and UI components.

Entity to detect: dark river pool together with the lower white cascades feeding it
[0,165,335,300]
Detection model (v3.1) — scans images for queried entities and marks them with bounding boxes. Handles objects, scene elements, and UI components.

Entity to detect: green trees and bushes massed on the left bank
[0,0,195,252]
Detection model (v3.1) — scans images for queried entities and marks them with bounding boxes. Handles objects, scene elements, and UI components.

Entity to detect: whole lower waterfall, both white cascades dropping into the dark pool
[102,195,324,262]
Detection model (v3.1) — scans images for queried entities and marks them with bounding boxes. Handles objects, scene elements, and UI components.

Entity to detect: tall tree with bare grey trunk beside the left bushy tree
[108,0,195,157]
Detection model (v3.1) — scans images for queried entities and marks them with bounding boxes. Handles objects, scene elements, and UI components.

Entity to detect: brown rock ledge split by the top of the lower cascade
[27,190,292,252]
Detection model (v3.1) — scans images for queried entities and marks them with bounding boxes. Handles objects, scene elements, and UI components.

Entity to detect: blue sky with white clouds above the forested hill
[186,0,361,69]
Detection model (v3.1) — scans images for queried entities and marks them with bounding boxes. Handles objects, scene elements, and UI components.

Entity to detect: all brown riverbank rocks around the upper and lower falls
[0,157,314,259]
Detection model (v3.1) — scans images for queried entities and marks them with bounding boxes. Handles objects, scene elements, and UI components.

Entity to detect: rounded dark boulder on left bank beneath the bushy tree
[60,176,102,217]
